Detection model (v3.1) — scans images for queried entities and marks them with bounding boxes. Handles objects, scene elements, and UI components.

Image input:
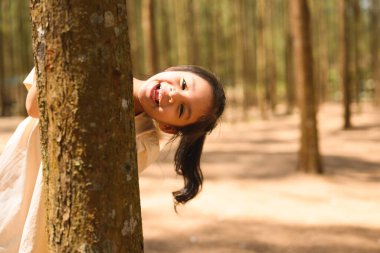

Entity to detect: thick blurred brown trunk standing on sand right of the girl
[289,0,323,173]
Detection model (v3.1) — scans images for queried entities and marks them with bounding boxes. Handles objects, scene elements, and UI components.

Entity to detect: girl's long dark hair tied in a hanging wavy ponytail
[165,65,226,205]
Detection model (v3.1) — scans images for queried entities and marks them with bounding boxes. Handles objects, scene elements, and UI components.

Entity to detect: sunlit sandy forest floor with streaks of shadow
[0,104,380,253]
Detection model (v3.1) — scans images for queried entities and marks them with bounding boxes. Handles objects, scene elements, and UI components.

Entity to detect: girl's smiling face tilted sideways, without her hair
[138,71,213,130]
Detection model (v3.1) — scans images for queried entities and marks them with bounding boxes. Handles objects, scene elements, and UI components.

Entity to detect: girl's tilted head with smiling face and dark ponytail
[138,66,226,206]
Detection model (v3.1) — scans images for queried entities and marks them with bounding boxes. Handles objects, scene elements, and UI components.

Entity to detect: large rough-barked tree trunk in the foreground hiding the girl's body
[31,0,143,253]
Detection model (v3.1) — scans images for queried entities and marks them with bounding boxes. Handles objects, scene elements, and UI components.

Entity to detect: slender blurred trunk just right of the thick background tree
[339,0,351,129]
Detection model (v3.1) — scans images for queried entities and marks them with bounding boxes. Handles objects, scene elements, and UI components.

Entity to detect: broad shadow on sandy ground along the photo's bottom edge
[145,220,380,253]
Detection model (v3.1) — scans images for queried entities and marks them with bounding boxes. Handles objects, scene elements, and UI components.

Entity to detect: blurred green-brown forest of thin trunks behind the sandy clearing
[0,0,380,118]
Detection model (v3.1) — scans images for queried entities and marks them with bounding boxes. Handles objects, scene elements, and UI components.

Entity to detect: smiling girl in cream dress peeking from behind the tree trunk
[0,66,225,253]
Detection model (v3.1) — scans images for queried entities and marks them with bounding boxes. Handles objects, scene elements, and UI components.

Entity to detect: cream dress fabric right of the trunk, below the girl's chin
[136,130,160,173]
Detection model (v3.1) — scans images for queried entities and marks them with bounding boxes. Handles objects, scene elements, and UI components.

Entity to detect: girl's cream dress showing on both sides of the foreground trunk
[0,70,159,253]
